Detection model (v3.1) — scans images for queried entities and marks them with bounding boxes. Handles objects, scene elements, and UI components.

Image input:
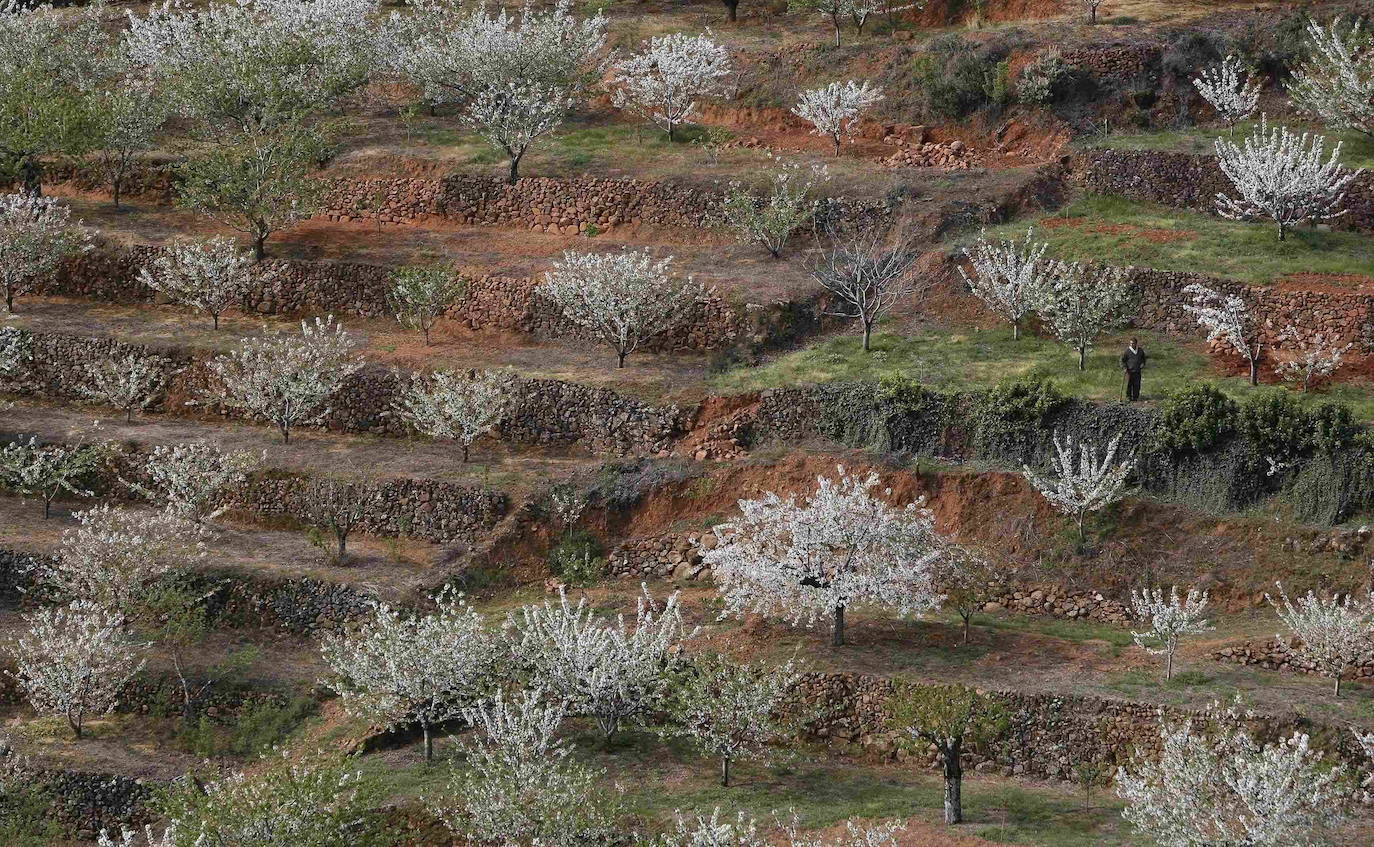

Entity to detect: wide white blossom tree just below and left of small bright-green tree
[206,315,363,441]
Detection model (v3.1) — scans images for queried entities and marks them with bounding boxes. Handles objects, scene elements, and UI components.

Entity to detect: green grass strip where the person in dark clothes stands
[712,329,1374,419]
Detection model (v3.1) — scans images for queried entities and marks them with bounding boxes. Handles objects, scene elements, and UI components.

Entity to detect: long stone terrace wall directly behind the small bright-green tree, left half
[48,245,747,355]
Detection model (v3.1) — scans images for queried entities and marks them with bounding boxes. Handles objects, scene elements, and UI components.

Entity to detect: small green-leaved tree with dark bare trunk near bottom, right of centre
[886,682,1007,824]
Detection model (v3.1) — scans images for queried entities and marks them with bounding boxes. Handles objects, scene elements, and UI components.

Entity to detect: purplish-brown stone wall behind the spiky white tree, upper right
[1070,149,1374,238]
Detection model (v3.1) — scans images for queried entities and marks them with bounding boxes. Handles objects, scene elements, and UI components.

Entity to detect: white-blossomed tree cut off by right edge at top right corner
[1287,18,1374,135]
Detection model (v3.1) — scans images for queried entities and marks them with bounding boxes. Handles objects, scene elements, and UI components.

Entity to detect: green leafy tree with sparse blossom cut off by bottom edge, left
[157,749,393,847]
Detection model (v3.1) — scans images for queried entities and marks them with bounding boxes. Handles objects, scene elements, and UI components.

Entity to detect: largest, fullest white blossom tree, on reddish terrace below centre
[702,468,940,646]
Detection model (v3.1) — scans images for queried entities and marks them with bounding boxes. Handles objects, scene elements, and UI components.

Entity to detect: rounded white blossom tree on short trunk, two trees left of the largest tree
[320,591,502,762]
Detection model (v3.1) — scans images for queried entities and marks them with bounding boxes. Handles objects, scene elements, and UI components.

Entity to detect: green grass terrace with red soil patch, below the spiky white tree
[969,194,1374,285]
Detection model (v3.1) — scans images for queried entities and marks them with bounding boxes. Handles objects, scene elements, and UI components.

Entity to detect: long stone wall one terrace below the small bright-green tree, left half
[16,327,692,455]
